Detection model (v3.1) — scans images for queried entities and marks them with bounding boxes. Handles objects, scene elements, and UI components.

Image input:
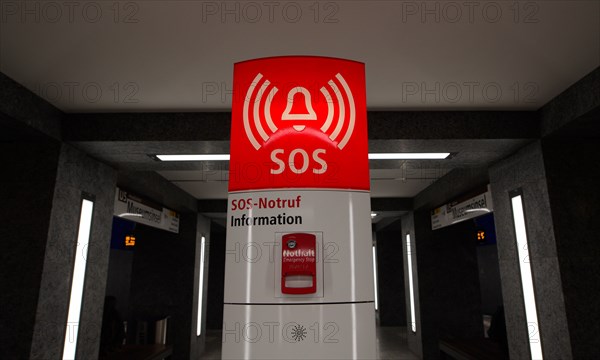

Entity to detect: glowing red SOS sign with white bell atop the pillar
[229,56,369,191]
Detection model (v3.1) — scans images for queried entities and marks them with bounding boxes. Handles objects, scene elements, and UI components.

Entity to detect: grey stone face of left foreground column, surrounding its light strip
[29,144,116,359]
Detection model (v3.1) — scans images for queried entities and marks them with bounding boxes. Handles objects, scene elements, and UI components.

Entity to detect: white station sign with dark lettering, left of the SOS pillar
[114,188,179,234]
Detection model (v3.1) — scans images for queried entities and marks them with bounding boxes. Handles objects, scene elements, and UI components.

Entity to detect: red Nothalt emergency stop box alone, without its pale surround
[281,233,317,294]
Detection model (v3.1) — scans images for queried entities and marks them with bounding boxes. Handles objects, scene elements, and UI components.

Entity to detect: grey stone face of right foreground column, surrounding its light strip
[490,141,573,360]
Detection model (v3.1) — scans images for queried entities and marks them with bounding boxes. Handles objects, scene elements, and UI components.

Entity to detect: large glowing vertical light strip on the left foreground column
[63,199,94,360]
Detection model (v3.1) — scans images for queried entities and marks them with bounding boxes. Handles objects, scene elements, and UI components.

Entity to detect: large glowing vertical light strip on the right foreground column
[511,194,544,360]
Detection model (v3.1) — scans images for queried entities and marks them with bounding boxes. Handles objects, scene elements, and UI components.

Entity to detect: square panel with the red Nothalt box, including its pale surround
[273,232,323,299]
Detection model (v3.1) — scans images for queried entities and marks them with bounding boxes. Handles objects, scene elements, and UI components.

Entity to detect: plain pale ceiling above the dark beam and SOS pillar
[0,0,600,112]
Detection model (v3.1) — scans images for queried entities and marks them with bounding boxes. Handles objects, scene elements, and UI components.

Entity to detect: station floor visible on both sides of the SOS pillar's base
[202,327,419,360]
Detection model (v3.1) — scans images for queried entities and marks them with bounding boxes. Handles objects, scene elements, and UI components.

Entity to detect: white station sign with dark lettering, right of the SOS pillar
[431,189,494,230]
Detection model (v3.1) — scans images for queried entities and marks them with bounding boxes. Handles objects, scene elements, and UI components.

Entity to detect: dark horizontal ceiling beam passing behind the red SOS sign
[62,111,540,142]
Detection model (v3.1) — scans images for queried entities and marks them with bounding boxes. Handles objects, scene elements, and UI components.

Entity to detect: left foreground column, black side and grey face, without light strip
[0,139,116,359]
